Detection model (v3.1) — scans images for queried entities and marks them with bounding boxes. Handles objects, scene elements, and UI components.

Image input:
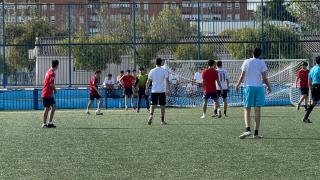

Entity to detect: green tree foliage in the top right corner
[287,1,320,34]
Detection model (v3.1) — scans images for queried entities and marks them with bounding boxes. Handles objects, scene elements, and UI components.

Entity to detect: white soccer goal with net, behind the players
[164,59,307,107]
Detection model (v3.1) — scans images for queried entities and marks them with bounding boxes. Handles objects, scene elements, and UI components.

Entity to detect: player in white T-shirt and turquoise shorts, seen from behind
[235,48,271,139]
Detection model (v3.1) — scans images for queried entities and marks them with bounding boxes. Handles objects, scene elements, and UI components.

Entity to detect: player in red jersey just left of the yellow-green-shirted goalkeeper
[120,70,135,110]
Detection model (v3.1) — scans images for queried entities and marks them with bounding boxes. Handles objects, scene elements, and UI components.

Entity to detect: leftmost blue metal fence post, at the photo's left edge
[2,1,8,88]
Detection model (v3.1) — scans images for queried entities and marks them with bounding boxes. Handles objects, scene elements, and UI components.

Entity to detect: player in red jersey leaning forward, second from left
[87,70,103,115]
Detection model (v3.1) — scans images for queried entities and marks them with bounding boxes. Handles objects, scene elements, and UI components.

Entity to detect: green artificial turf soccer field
[0,107,320,180]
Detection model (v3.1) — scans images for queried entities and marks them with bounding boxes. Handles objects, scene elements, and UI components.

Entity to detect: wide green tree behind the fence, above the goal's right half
[221,25,308,59]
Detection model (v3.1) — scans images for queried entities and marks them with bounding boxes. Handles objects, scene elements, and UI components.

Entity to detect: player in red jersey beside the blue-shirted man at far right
[296,62,309,111]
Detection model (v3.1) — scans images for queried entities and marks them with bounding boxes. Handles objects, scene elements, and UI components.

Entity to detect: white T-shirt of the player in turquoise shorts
[241,58,268,86]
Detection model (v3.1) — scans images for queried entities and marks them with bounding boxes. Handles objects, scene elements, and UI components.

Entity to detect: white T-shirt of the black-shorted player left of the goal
[148,67,169,93]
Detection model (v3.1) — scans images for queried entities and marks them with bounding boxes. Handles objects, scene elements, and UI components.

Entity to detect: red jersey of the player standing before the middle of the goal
[202,68,219,93]
